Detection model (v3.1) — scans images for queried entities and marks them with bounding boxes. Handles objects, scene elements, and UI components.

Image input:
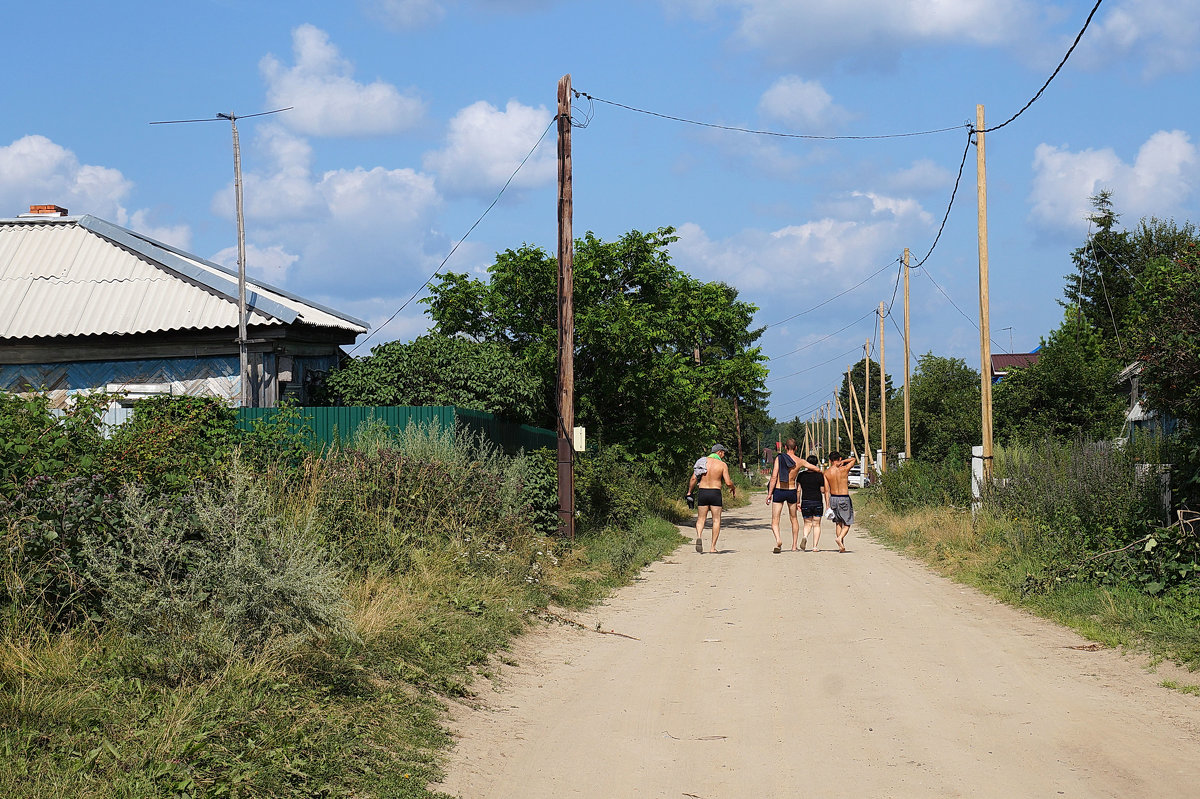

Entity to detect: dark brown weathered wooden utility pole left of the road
[557,74,575,540]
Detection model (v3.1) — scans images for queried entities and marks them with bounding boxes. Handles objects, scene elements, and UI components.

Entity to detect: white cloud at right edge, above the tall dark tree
[1030,131,1200,232]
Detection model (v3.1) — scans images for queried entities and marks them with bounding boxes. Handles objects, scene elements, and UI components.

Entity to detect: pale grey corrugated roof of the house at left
[0,216,368,338]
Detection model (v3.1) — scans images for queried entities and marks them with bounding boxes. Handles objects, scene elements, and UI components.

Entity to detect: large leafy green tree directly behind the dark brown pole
[425,228,767,475]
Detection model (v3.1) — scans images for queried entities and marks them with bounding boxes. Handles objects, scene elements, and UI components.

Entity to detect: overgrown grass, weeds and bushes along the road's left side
[0,396,683,799]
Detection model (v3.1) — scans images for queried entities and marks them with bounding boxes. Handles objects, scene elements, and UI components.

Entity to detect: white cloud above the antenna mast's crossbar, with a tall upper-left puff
[259,24,425,136]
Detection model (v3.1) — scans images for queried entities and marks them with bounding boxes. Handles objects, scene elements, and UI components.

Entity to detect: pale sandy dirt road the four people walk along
[438,501,1200,799]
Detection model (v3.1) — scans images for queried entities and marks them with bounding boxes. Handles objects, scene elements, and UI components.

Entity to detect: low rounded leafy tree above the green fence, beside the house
[325,336,544,422]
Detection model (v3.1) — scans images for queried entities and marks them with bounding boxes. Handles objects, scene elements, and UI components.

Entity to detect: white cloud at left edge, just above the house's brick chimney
[0,136,133,222]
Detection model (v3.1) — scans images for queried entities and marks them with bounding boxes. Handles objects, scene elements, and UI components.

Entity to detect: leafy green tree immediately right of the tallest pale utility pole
[992,308,1124,440]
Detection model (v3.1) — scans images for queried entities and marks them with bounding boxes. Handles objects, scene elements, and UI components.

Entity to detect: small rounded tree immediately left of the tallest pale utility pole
[907,353,982,463]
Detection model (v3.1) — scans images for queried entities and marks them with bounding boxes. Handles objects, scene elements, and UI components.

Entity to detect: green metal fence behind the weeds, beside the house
[238,405,558,455]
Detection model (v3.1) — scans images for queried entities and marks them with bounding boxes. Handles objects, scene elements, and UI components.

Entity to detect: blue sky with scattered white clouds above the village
[0,0,1200,420]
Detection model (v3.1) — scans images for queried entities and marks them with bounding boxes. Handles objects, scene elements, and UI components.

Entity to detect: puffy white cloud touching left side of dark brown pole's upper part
[424,100,556,194]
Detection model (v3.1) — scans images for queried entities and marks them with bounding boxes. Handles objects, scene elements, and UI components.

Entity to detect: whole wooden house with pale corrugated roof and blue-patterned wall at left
[0,205,368,407]
